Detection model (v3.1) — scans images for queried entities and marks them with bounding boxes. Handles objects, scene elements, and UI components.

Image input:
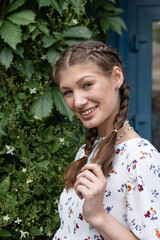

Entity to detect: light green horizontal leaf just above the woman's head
[63,26,93,39]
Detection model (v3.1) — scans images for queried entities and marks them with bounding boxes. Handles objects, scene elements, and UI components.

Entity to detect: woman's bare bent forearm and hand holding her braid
[75,163,138,240]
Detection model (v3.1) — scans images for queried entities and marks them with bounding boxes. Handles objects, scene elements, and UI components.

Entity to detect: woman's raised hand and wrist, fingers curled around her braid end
[74,163,107,226]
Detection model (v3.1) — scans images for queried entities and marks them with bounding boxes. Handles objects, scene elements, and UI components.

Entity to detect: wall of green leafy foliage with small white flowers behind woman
[0,0,125,240]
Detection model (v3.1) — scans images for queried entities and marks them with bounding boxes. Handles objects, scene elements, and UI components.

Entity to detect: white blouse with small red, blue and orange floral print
[53,138,160,240]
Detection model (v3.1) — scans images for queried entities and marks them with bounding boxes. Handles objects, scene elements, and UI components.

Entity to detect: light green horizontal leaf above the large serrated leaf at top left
[7,10,36,25]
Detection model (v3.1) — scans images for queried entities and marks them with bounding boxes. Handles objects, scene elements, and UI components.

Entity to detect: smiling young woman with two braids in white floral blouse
[53,41,160,240]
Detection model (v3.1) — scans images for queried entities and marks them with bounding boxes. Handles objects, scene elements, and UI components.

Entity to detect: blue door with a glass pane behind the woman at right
[126,0,160,150]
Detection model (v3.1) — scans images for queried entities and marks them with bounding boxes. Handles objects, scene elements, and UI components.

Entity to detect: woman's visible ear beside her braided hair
[112,66,124,88]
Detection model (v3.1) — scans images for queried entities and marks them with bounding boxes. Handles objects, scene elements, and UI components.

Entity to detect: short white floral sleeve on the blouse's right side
[126,145,160,240]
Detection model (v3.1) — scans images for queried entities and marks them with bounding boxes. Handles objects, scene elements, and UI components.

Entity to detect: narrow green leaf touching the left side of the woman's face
[53,87,74,121]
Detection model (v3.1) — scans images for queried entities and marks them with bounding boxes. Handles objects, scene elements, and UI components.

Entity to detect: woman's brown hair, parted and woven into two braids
[54,41,130,188]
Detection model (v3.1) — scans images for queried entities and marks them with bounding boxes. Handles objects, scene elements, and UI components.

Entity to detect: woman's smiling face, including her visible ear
[59,63,123,136]
